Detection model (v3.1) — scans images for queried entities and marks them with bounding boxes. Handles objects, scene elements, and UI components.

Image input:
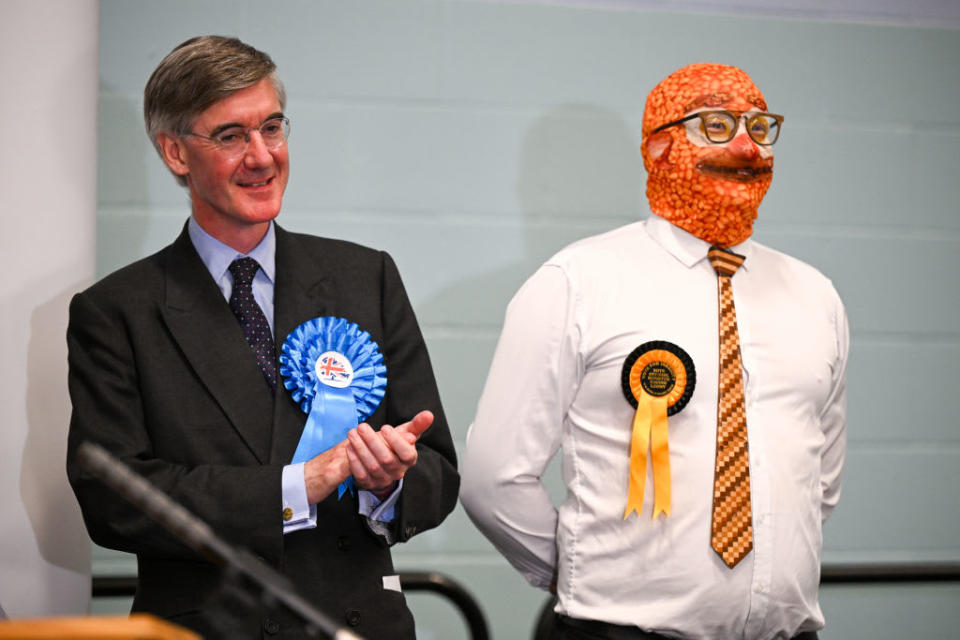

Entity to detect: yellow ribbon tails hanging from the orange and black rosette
[623,391,670,520]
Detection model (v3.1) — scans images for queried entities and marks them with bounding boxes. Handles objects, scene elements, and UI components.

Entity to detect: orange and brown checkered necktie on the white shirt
[707,247,753,569]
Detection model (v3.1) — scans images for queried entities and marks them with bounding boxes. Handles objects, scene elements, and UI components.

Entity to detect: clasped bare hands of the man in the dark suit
[304,411,433,504]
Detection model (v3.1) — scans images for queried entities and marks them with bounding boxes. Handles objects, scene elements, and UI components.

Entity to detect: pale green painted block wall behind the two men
[95,0,960,640]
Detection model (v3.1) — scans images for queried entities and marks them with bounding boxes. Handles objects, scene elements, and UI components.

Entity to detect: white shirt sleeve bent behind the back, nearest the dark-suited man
[460,265,582,588]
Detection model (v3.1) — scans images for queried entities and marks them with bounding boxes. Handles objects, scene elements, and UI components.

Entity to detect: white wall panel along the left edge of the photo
[0,0,97,617]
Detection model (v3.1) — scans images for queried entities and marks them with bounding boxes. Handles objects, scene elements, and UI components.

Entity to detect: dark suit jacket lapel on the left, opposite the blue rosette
[162,226,274,463]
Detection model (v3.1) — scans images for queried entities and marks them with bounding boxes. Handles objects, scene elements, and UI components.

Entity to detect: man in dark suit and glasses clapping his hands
[67,36,459,639]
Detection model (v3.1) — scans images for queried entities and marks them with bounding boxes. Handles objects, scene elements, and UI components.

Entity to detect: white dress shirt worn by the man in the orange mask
[461,215,849,639]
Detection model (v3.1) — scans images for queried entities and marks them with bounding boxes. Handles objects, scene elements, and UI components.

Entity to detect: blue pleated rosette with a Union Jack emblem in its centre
[280,316,387,497]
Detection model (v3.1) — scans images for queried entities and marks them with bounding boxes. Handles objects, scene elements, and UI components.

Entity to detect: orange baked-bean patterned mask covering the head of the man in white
[641,63,773,247]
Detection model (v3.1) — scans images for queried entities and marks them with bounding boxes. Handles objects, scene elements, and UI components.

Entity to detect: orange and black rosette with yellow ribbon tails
[621,340,697,520]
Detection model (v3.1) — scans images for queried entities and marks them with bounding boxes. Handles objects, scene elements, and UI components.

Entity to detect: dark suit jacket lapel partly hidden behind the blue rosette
[270,223,335,464]
